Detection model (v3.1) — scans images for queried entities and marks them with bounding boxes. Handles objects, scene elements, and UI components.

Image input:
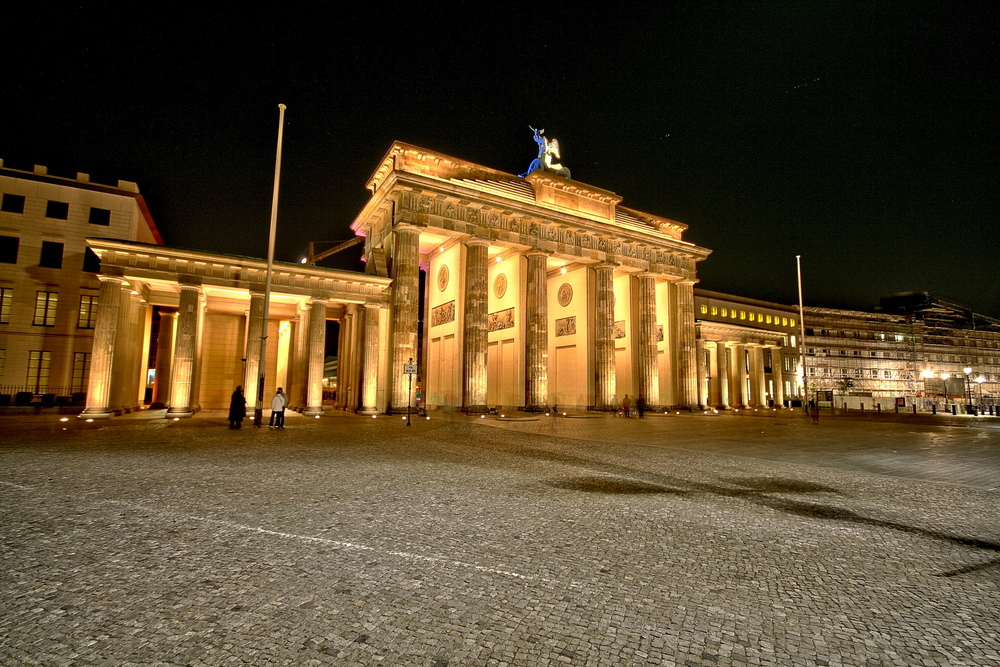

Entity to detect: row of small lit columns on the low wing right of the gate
[697,341,785,408]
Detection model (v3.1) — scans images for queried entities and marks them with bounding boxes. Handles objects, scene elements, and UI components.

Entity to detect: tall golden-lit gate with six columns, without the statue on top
[351,142,710,412]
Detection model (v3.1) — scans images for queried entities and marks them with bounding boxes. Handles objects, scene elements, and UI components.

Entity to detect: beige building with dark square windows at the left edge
[0,161,162,401]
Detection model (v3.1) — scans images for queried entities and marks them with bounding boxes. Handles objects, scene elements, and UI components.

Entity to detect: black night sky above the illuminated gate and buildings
[0,1,1000,317]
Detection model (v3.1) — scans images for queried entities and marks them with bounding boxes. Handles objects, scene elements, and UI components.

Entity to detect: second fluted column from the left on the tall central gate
[462,238,490,413]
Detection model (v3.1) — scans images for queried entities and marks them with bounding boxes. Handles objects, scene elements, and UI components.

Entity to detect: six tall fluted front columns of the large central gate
[389,224,698,412]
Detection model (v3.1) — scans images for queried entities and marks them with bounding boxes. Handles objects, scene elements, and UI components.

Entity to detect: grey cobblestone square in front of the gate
[0,414,1000,667]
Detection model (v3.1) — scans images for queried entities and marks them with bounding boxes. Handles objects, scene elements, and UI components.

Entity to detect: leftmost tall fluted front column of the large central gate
[389,224,420,412]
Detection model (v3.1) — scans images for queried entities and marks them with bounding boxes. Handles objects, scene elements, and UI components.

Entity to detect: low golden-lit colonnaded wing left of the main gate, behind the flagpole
[81,239,390,418]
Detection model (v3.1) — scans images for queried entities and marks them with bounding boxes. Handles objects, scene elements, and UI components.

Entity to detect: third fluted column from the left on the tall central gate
[524,250,549,412]
